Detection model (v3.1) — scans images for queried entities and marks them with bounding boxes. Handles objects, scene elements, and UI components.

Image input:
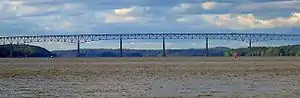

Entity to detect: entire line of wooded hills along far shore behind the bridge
[0,45,300,57]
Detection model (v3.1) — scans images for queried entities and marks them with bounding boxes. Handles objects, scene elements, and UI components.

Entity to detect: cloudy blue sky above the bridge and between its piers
[0,0,300,50]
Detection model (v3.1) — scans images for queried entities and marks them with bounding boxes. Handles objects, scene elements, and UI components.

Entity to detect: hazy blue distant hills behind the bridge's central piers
[52,47,230,57]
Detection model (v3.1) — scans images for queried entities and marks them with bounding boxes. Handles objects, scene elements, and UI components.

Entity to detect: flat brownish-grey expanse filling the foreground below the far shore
[0,57,300,98]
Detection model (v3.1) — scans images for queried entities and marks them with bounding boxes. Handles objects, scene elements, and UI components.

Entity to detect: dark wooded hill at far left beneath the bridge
[0,45,56,58]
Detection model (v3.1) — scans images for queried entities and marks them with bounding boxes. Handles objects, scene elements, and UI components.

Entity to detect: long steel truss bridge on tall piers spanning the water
[0,32,300,57]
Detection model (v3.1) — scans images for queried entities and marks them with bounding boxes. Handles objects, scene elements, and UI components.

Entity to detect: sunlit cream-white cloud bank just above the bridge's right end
[200,13,300,29]
